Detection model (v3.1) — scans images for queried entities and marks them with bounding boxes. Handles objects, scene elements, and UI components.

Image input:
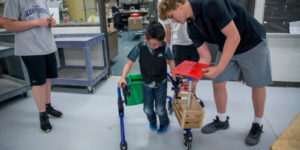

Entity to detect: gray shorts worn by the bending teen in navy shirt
[213,40,272,87]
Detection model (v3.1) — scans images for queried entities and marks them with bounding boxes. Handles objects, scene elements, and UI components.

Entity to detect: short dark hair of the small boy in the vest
[146,21,165,41]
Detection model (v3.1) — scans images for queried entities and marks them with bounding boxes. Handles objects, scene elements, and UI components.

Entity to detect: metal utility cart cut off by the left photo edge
[0,42,30,102]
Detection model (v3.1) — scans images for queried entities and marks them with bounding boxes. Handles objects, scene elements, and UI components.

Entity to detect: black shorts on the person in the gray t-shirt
[22,53,57,85]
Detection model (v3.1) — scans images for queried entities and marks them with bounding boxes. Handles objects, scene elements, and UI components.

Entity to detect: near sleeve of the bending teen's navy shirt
[206,0,236,30]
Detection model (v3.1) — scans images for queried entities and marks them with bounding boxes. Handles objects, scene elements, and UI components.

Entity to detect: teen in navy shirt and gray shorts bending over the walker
[159,0,272,145]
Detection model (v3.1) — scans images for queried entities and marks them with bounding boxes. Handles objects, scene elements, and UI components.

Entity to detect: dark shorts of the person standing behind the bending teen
[172,45,199,66]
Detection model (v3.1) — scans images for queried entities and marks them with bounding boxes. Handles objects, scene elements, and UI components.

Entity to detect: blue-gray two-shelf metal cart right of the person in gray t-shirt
[52,33,108,93]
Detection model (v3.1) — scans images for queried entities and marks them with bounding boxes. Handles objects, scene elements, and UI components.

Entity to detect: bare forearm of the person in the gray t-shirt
[4,18,51,32]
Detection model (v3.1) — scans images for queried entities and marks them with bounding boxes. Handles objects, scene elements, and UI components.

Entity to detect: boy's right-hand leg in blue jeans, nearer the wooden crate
[154,82,170,133]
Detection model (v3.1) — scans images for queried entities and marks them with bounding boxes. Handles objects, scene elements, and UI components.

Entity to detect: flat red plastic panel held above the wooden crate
[171,60,210,79]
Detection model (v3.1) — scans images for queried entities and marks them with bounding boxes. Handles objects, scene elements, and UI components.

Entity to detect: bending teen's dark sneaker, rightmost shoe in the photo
[245,123,263,146]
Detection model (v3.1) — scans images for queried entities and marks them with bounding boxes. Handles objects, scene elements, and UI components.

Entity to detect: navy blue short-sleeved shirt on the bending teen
[187,0,266,55]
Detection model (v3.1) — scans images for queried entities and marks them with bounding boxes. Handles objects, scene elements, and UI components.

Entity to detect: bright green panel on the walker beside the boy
[126,73,143,106]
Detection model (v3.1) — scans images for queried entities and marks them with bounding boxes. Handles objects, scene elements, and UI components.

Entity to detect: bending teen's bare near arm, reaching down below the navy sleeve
[200,20,241,79]
